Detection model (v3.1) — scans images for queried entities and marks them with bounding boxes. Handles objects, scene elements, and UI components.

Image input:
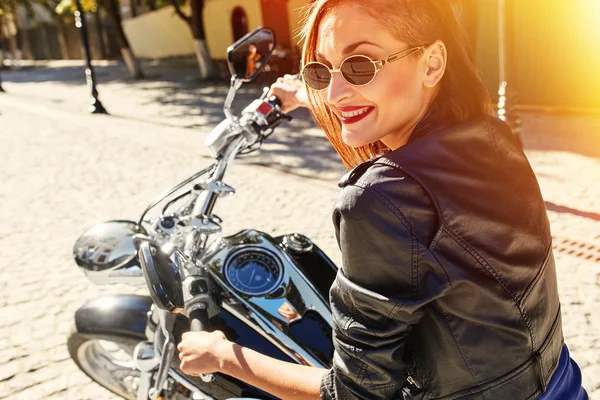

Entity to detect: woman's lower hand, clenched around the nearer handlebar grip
[177,331,233,375]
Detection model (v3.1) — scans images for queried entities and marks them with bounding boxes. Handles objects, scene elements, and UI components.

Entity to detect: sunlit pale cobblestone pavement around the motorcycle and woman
[0,64,600,400]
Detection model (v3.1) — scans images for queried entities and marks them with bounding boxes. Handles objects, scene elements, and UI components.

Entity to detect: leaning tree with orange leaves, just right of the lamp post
[56,0,144,79]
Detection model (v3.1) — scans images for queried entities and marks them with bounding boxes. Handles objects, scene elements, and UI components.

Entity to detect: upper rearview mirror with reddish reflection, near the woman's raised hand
[227,28,275,82]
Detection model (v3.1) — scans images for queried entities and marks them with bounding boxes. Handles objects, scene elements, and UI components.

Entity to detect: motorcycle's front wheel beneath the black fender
[67,332,140,400]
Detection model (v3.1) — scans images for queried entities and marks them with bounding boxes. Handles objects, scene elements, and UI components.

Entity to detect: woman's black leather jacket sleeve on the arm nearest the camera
[321,182,448,400]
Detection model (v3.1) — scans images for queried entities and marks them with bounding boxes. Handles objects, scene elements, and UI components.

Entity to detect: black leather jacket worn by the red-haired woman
[321,117,563,400]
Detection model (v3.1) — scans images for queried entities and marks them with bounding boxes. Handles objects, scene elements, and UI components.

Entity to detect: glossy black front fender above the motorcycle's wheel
[75,294,152,340]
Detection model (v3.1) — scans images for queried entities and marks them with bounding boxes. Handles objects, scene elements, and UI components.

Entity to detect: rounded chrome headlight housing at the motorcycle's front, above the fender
[73,221,145,285]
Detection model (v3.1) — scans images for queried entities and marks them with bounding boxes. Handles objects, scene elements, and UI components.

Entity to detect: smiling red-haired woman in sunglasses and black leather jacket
[179,0,587,400]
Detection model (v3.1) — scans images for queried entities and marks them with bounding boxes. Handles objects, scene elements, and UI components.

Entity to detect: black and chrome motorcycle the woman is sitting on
[68,28,337,400]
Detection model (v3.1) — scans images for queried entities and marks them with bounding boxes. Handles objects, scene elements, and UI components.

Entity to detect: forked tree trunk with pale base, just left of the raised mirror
[170,0,215,80]
